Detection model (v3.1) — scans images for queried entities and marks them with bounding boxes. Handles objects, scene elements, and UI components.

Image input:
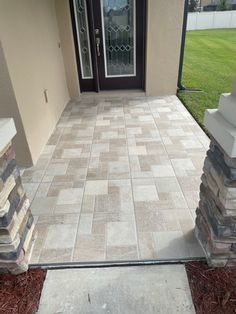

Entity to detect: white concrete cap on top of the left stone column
[0,118,16,152]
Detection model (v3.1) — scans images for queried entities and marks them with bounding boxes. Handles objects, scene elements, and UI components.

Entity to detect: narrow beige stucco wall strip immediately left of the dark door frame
[55,0,80,99]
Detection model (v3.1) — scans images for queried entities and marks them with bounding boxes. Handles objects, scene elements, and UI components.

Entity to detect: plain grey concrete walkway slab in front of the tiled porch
[38,265,195,314]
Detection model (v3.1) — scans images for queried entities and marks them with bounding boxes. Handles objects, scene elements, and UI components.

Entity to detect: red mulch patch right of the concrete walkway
[185,262,236,314]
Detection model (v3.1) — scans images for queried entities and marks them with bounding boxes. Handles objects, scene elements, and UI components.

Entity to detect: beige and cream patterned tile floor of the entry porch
[23,95,209,263]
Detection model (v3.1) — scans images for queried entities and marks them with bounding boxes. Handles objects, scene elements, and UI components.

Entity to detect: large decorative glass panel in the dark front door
[101,0,136,77]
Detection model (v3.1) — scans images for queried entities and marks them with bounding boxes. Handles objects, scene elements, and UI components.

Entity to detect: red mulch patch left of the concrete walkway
[0,269,46,314]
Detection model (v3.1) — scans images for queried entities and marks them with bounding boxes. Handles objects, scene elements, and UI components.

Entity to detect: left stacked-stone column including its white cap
[0,119,35,274]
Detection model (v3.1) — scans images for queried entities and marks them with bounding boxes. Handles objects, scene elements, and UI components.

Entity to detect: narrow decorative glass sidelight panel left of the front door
[74,0,93,79]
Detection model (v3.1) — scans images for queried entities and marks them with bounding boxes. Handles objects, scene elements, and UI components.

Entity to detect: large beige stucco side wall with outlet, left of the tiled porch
[0,0,69,165]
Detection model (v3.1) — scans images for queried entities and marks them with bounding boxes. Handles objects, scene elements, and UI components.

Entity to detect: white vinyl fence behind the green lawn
[187,11,236,31]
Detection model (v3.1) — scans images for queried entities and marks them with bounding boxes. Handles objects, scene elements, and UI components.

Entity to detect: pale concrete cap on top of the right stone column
[204,109,236,158]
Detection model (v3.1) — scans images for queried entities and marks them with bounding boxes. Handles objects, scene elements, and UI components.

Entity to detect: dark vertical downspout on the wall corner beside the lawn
[178,0,189,90]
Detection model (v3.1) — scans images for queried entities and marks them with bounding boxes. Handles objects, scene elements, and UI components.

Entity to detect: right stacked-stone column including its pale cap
[195,80,236,267]
